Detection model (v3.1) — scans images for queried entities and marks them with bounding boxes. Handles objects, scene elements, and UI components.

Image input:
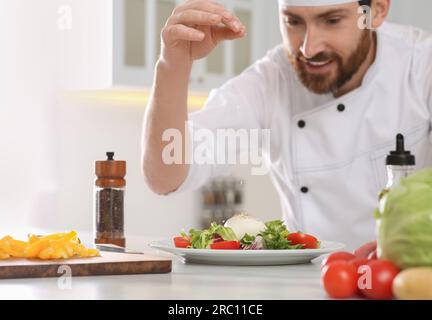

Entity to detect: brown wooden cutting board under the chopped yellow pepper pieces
[0,252,172,279]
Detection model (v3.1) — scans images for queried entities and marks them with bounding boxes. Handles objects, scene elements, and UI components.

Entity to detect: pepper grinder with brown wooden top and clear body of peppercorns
[94,152,126,247]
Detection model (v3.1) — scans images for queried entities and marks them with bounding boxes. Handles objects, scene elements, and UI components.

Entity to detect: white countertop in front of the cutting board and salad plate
[0,232,328,300]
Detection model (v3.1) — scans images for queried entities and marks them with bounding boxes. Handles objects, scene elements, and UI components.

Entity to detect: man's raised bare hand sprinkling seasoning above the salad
[161,0,246,65]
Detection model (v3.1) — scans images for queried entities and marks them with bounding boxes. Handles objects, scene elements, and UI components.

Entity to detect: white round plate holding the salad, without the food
[150,241,345,266]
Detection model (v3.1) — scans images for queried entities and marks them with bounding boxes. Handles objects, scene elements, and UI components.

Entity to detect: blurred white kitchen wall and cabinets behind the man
[0,0,432,237]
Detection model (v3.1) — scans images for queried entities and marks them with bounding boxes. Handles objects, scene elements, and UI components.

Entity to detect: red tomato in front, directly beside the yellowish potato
[359,260,400,300]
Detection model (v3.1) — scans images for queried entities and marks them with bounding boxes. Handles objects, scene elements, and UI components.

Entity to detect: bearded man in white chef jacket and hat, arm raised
[142,0,432,248]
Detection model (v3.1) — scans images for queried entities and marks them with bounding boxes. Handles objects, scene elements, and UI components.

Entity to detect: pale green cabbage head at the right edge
[378,168,432,269]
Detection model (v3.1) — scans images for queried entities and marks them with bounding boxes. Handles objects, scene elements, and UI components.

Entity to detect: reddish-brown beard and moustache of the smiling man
[288,30,373,94]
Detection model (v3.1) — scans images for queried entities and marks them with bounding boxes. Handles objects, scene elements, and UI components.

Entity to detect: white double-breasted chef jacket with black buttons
[170,23,432,248]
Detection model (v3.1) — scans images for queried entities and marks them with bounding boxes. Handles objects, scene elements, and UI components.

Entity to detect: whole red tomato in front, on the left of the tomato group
[322,260,358,299]
